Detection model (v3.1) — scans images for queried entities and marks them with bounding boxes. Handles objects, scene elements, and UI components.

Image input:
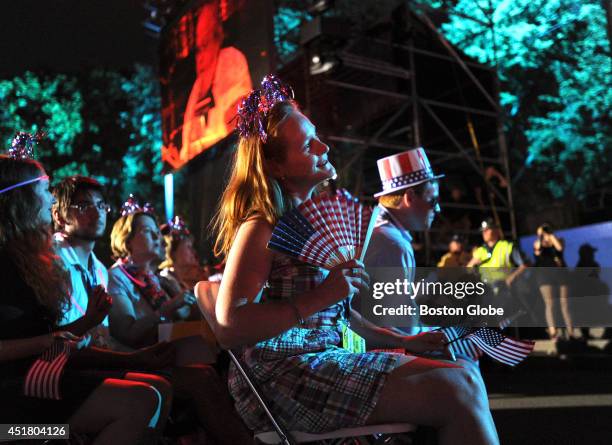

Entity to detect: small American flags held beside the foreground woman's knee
[448,326,535,366]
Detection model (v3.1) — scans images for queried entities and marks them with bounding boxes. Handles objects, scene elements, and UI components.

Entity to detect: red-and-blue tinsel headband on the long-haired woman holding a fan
[237,74,293,143]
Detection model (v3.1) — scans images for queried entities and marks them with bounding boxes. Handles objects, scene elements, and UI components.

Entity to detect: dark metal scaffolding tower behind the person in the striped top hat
[280,1,517,264]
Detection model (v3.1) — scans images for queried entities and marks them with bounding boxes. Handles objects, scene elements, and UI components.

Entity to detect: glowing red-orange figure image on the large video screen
[160,0,272,170]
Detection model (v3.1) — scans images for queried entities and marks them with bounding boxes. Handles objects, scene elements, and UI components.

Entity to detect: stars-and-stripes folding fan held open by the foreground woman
[268,189,379,269]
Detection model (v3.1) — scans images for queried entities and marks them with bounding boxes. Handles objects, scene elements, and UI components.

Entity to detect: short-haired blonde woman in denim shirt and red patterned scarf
[108,205,252,444]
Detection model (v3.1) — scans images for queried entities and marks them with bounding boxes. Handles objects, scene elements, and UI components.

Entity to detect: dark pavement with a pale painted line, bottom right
[482,340,612,445]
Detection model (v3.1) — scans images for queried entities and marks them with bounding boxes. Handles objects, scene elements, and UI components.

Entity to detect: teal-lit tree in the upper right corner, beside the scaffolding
[442,0,612,198]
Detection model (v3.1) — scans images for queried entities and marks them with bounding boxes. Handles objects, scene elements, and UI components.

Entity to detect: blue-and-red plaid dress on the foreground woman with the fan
[229,254,398,433]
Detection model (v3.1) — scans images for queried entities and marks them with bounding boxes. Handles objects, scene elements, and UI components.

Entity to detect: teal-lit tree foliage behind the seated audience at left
[0,65,162,208]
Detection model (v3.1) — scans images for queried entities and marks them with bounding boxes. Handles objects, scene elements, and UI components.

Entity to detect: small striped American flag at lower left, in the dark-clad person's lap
[24,341,70,400]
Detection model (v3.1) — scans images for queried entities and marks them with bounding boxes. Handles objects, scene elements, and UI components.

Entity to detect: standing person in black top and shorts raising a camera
[533,223,574,340]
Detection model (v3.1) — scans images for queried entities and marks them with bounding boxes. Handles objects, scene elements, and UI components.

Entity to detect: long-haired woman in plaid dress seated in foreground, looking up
[203,77,498,445]
